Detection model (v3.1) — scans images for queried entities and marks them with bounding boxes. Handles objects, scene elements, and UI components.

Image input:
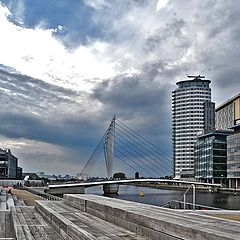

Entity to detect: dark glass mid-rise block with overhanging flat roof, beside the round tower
[195,130,231,185]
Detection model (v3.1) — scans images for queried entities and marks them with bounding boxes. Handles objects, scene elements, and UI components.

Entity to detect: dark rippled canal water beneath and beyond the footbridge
[86,185,240,210]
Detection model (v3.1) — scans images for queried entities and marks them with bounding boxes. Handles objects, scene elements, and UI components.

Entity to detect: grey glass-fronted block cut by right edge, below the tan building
[227,121,240,188]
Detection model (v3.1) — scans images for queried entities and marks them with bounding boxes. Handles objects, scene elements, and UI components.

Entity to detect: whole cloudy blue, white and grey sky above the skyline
[0,0,240,176]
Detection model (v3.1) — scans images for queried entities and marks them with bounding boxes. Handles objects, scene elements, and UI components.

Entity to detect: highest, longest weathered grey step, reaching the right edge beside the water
[64,194,240,240]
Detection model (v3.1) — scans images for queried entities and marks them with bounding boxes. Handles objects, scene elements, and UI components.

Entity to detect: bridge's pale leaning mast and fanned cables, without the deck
[80,117,173,179]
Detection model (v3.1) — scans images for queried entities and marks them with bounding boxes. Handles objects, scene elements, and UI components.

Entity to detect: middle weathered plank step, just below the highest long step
[35,201,146,240]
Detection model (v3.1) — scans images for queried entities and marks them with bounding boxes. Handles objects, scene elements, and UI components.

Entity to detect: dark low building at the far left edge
[0,148,18,179]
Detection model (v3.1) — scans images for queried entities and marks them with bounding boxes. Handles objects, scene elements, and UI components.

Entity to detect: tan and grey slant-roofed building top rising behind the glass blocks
[215,93,240,130]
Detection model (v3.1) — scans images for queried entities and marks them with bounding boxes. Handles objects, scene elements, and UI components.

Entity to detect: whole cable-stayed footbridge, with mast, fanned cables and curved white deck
[48,117,221,195]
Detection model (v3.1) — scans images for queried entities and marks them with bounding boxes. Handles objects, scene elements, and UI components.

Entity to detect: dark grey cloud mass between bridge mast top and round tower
[92,63,172,150]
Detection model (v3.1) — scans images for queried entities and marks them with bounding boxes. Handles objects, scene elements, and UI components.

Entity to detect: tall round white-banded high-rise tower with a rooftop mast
[172,75,211,179]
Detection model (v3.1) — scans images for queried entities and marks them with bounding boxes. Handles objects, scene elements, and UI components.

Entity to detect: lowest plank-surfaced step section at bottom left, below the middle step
[11,206,64,240]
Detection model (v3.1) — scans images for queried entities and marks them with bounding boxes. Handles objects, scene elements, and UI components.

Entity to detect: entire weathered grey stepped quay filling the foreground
[0,190,240,240]
